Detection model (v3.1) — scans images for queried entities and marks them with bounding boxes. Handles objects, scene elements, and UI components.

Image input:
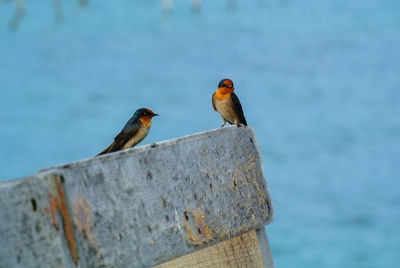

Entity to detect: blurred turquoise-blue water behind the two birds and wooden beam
[0,0,400,267]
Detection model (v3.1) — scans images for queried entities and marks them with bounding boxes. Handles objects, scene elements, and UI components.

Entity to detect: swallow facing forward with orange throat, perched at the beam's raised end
[212,79,247,127]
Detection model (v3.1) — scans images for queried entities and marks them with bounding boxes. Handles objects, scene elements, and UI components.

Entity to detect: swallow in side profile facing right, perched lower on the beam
[97,108,158,156]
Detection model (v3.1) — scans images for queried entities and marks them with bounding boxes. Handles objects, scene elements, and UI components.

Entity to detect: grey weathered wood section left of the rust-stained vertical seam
[0,174,76,267]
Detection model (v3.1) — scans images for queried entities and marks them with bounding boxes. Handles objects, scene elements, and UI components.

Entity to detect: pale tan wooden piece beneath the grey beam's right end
[154,228,274,268]
